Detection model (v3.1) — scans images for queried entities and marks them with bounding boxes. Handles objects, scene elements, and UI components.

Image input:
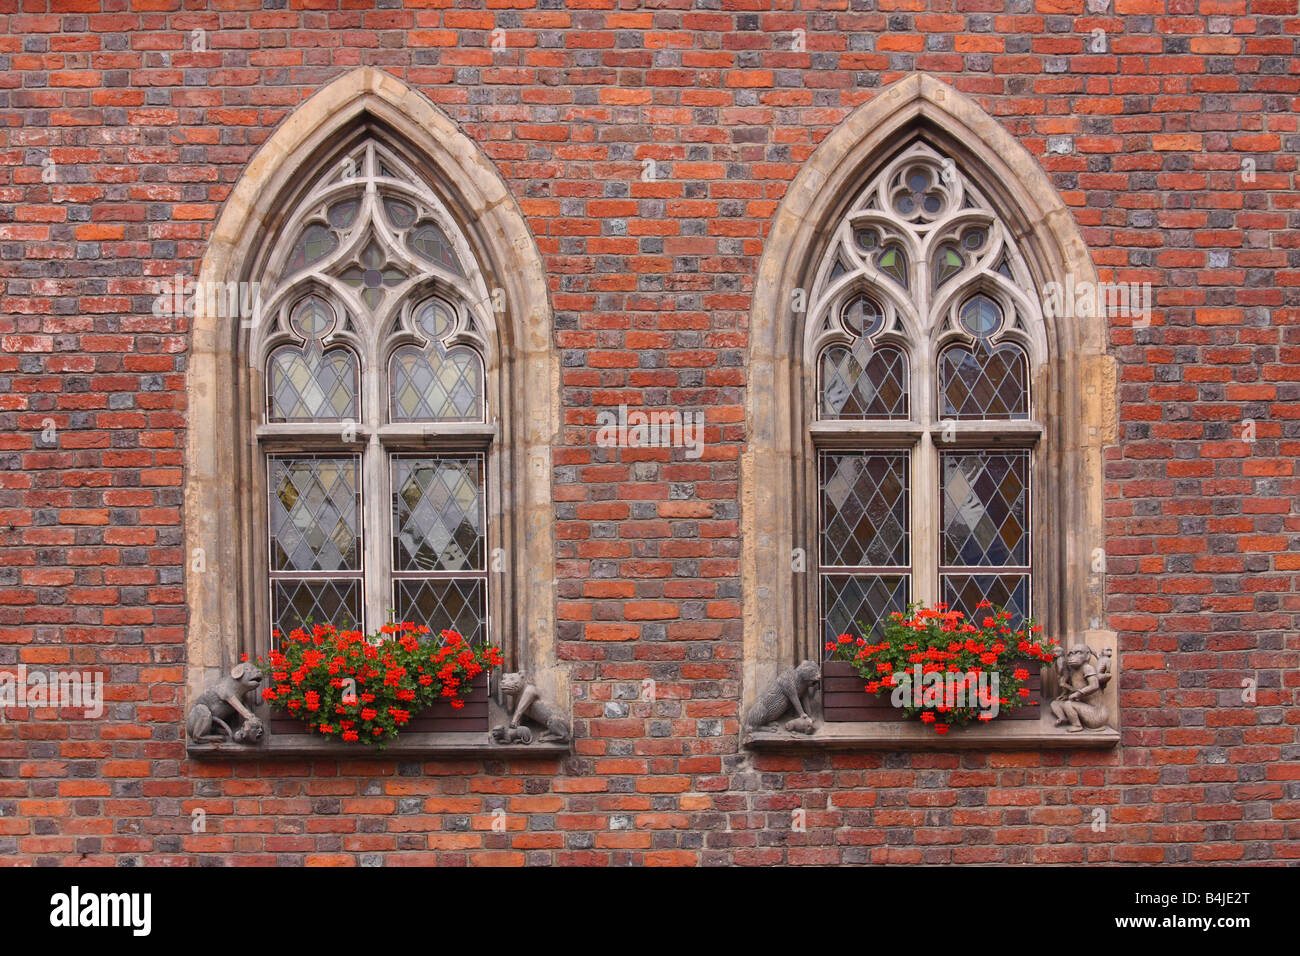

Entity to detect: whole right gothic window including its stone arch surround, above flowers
[742,74,1114,749]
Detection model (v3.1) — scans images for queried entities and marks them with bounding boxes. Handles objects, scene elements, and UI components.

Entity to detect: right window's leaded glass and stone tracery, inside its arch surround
[805,140,1047,643]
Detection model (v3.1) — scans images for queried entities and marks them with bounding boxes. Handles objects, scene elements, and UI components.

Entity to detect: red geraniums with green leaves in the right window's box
[826,601,1057,734]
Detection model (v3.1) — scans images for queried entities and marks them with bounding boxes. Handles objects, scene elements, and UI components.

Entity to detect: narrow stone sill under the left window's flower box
[185,734,571,761]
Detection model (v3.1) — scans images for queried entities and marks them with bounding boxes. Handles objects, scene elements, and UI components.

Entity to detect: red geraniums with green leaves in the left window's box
[257,622,504,749]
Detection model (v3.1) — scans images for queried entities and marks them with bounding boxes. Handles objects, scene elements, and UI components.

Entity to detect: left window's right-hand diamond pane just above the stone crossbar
[390,345,484,421]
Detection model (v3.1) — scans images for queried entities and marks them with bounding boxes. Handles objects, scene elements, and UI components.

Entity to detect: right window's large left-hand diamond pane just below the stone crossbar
[822,454,910,567]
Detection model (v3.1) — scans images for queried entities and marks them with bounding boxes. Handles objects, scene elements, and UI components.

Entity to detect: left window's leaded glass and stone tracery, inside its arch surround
[250,135,497,641]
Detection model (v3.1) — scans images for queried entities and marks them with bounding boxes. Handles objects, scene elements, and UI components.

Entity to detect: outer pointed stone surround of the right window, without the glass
[741,74,1115,712]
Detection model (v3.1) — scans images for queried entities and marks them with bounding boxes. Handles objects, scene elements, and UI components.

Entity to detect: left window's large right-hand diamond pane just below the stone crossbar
[393,458,484,571]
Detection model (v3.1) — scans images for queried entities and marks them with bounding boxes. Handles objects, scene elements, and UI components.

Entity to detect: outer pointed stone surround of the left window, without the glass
[185,68,567,701]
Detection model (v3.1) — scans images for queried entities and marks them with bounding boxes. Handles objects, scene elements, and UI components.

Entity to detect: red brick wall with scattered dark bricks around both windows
[0,0,1300,864]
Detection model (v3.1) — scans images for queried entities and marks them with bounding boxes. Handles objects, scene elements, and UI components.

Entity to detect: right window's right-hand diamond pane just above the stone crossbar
[939,343,1030,419]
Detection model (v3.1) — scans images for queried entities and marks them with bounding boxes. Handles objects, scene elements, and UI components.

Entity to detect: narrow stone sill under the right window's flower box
[745,718,1119,750]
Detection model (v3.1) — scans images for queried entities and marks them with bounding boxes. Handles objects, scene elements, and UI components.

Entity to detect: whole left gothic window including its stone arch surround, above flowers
[186,68,568,738]
